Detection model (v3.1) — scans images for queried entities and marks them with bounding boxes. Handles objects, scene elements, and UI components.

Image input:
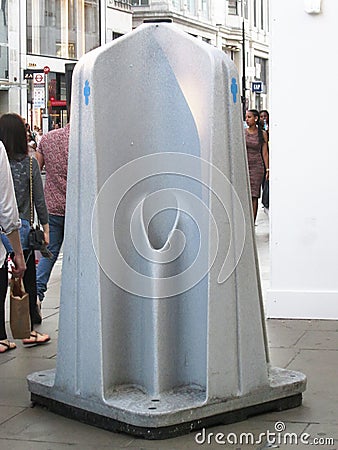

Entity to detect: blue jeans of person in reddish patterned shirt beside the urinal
[36,214,65,301]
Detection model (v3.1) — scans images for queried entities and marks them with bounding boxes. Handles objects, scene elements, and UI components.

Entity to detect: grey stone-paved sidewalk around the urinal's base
[0,209,338,450]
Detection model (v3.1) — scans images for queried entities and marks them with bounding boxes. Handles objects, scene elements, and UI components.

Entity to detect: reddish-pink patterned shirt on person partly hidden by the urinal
[37,124,70,216]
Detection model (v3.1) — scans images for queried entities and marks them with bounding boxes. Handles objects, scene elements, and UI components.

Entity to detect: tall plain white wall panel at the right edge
[266,0,338,319]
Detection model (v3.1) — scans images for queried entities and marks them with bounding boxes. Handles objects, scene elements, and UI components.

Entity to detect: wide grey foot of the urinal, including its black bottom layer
[28,367,306,440]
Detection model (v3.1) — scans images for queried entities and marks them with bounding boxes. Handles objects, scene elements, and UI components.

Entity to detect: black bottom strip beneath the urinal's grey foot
[31,393,302,439]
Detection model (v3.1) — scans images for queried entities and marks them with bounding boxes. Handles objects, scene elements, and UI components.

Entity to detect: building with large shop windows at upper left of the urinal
[0,0,132,128]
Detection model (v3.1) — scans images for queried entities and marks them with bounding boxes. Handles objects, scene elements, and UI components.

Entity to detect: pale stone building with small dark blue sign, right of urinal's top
[131,0,270,110]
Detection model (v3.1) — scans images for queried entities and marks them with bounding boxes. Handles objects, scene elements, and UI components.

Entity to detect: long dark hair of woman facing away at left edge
[0,113,28,161]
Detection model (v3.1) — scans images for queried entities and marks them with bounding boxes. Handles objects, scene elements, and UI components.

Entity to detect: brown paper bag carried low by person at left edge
[9,278,31,339]
